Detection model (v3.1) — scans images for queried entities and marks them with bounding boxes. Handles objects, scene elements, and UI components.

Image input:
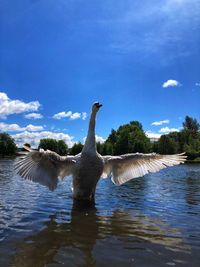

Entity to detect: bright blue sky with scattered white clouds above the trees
[0,0,200,146]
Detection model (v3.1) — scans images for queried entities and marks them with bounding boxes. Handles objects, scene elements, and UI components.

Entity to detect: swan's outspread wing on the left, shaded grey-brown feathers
[15,149,77,190]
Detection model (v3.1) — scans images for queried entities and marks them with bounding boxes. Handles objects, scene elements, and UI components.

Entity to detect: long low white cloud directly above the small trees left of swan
[12,131,75,148]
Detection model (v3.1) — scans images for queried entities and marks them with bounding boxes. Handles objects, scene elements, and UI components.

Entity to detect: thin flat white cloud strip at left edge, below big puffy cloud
[0,122,44,132]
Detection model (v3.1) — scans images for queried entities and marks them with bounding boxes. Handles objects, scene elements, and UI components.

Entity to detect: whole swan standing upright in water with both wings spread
[15,102,186,200]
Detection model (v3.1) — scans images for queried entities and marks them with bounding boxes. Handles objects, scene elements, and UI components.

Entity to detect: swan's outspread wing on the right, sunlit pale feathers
[102,153,186,185]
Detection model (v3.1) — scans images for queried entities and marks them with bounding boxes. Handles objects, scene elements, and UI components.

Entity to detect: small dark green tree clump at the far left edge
[0,133,17,156]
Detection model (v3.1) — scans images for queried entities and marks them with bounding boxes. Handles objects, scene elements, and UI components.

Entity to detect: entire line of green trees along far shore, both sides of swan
[0,116,200,160]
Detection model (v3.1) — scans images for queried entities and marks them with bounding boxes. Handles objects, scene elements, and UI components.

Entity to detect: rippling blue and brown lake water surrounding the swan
[0,160,200,267]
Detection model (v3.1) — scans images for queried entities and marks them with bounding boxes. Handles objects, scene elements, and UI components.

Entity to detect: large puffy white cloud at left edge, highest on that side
[0,92,40,119]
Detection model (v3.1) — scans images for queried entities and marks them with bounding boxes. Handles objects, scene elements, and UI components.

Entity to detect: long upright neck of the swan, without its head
[82,111,96,153]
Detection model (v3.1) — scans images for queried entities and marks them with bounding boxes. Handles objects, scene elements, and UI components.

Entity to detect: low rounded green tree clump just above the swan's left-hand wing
[38,138,68,155]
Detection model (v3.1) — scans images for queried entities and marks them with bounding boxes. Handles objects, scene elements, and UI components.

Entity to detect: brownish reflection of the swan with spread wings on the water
[9,207,188,266]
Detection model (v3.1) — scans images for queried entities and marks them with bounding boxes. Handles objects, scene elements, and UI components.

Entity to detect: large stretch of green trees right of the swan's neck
[97,116,200,160]
